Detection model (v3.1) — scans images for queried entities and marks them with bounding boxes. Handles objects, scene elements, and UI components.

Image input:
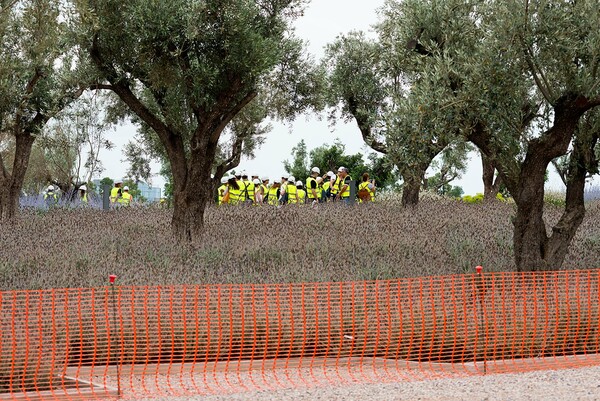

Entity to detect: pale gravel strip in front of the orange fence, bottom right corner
[122,366,600,401]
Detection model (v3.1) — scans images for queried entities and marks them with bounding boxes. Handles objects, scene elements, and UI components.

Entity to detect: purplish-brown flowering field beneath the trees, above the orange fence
[0,198,600,290]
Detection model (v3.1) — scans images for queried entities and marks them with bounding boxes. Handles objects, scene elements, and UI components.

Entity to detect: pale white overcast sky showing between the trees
[101,0,563,195]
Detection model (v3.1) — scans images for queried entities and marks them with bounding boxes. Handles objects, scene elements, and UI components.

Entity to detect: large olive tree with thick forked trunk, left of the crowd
[77,0,312,240]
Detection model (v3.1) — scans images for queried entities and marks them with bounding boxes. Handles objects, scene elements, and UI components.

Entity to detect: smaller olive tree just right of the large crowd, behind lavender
[324,30,464,206]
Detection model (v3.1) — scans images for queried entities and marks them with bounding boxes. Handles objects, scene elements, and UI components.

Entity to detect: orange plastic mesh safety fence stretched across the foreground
[0,270,600,399]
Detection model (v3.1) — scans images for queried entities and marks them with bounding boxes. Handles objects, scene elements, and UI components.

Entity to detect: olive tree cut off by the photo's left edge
[0,0,83,220]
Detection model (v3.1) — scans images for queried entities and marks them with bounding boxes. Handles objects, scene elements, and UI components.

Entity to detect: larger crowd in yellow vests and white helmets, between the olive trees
[218,167,376,206]
